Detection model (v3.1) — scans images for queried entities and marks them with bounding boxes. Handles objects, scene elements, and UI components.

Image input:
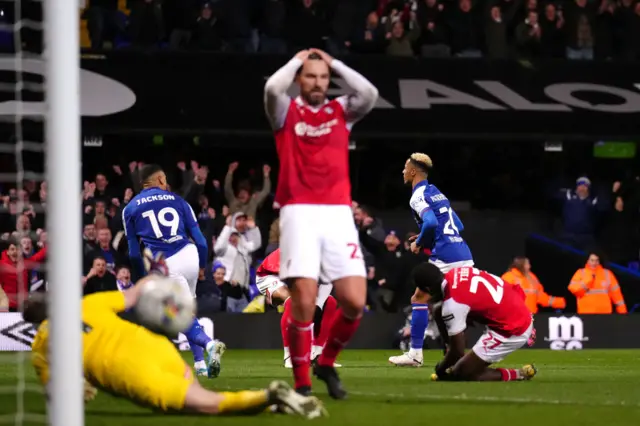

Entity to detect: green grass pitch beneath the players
[0,350,640,426]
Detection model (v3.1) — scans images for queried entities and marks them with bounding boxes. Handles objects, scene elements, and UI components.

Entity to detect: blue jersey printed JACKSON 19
[122,187,198,258]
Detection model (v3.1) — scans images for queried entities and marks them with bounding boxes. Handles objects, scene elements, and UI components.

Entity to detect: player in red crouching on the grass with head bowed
[412,263,537,381]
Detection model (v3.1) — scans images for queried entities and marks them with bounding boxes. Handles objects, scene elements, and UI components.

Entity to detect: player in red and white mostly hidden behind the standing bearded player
[256,249,341,368]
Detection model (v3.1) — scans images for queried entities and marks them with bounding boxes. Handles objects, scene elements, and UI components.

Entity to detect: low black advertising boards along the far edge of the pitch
[0,312,640,351]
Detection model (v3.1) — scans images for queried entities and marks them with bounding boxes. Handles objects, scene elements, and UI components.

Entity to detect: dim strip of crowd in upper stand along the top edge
[77,0,640,59]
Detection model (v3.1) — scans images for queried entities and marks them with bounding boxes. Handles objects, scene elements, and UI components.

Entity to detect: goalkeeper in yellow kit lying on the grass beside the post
[23,256,326,418]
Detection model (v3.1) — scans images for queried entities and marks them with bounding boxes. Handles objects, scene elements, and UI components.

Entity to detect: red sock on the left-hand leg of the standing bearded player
[287,318,313,389]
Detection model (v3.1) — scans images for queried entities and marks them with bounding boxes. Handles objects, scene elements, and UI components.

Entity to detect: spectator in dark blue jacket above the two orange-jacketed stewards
[562,176,604,250]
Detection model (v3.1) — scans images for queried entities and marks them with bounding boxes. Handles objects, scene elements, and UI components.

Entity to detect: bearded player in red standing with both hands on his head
[264,49,378,399]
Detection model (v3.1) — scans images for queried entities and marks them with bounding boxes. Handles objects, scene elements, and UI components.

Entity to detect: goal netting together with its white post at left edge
[0,0,84,426]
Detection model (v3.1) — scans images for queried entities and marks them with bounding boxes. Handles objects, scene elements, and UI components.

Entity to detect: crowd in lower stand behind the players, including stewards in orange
[0,161,640,312]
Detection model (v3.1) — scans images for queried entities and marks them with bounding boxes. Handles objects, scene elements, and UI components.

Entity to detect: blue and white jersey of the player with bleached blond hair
[409,180,473,263]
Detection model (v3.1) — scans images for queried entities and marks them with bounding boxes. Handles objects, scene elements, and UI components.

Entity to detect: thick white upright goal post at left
[43,0,84,426]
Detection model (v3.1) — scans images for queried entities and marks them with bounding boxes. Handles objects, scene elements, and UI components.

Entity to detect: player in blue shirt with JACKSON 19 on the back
[122,165,225,377]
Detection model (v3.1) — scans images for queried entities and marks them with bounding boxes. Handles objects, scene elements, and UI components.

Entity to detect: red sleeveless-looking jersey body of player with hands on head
[275,98,351,206]
